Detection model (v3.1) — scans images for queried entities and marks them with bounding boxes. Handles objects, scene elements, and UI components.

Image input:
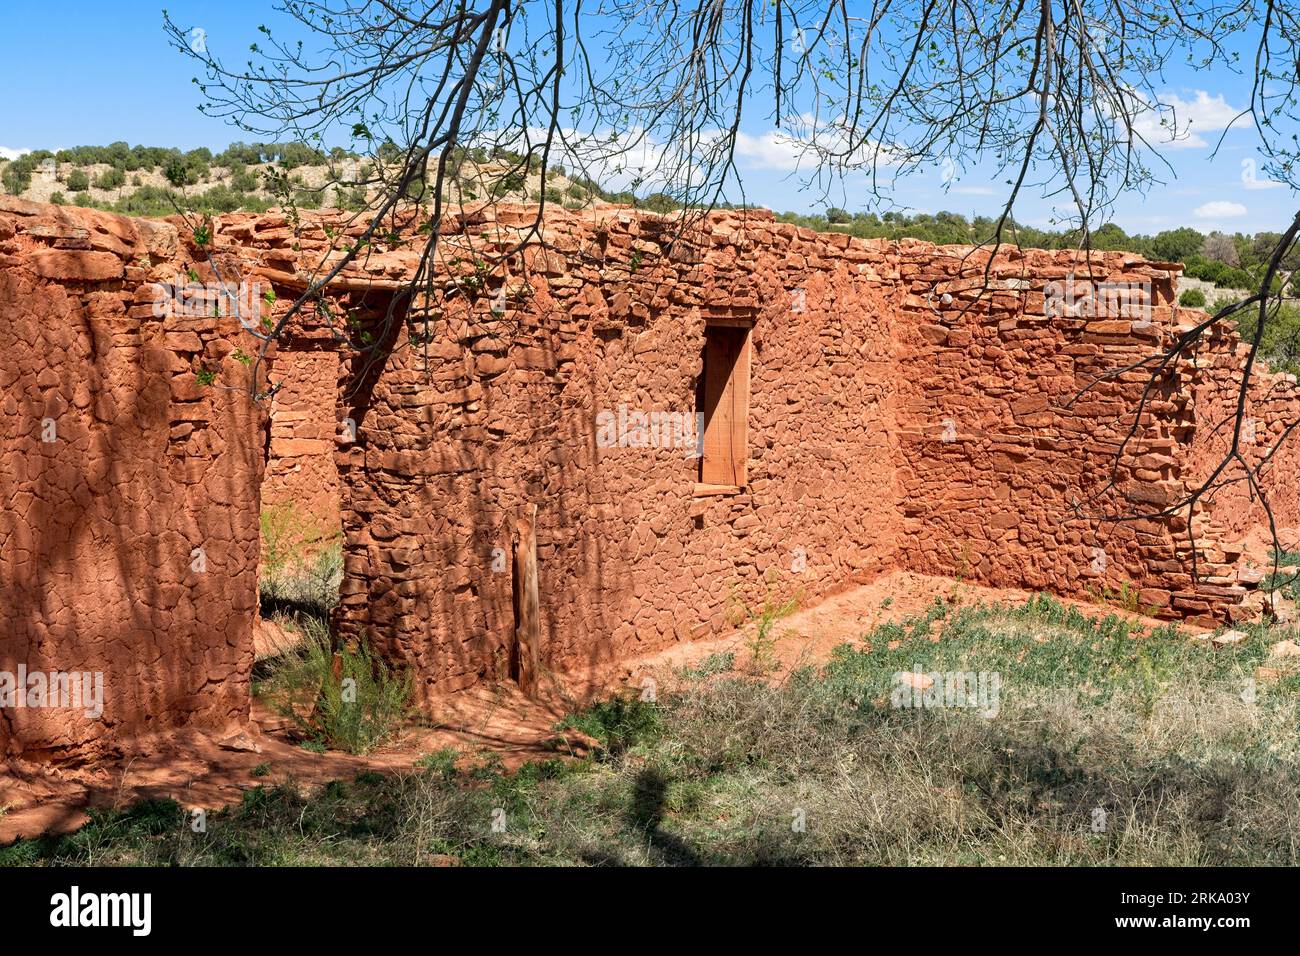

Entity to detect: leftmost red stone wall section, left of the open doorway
[0,199,261,760]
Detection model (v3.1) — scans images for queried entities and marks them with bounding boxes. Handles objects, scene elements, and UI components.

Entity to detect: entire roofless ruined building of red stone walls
[0,198,1300,760]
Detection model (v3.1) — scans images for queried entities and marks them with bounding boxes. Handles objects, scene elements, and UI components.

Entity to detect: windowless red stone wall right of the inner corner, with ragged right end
[898,242,1182,605]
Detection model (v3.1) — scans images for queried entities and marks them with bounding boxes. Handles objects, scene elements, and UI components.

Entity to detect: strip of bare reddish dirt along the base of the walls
[0,571,1180,844]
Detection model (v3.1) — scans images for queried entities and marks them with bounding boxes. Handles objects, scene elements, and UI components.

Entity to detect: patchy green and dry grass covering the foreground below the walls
[10,597,1300,865]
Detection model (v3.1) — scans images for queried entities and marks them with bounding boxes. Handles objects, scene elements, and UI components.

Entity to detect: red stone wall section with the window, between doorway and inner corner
[330,213,898,691]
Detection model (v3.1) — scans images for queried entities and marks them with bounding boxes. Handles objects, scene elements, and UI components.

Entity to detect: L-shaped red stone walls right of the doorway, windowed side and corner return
[213,208,1300,692]
